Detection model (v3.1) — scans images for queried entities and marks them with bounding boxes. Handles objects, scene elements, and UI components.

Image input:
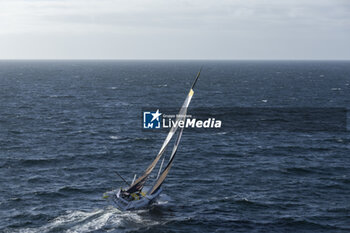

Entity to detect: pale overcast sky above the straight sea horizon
[0,0,350,59]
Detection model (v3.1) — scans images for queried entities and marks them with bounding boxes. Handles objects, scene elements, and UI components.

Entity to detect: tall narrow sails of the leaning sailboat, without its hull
[126,70,201,193]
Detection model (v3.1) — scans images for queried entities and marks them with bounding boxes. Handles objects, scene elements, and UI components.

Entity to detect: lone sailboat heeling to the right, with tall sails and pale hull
[105,70,201,211]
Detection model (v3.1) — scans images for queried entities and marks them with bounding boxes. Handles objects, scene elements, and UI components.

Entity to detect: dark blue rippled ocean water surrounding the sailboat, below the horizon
[0,61,350,232]
